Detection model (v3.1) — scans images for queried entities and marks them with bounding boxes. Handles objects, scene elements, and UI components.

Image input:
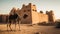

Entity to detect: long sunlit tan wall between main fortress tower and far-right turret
[32,11,48,24]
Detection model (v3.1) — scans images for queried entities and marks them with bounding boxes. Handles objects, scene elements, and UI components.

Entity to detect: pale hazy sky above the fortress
[0,0,60,19]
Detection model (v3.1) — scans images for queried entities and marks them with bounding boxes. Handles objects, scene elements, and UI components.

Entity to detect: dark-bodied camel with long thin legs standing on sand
[7,13,21,31]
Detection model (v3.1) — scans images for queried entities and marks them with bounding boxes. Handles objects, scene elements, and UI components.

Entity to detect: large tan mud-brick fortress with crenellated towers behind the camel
[10,3,55,24]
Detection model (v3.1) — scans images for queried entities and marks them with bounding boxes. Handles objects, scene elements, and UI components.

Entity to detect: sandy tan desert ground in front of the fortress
[0,24,60,34]
